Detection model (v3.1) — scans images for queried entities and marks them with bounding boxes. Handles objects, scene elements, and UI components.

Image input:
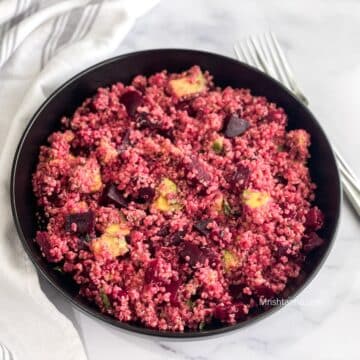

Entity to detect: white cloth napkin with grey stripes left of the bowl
[0,0,157,360]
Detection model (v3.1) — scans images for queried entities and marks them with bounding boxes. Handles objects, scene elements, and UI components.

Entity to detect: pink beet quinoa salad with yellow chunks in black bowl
[33,66,324,332]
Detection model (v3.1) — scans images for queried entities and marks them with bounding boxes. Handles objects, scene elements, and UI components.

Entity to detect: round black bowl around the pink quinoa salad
[11,49,341,338]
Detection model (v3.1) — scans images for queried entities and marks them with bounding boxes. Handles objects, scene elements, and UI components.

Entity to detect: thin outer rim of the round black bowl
[10,48,343,340]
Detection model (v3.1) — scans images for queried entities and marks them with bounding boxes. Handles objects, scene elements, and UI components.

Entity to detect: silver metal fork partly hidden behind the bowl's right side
[234,32,360,216]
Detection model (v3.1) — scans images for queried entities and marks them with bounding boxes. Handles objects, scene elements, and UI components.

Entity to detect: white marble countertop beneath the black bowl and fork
[35,0,360,360]
